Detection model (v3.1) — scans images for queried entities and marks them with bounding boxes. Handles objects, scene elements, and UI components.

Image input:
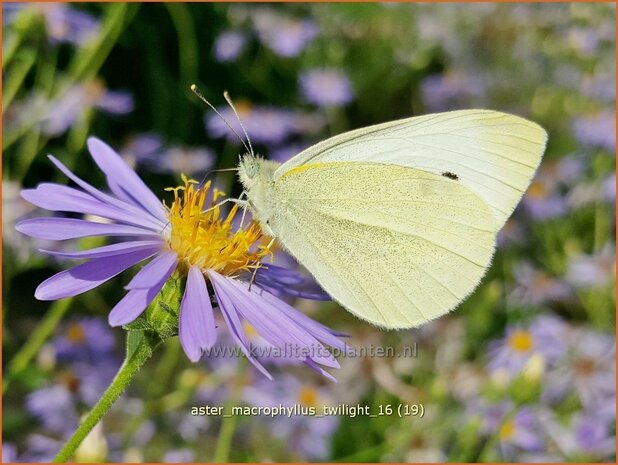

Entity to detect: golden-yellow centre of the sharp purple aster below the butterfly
[166,175,270,276]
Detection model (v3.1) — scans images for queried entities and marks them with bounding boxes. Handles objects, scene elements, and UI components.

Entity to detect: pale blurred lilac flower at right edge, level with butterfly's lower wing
[566,243,616,289]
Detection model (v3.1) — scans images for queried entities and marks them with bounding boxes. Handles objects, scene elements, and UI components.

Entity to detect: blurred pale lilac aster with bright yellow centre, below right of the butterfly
[488,315,568,378]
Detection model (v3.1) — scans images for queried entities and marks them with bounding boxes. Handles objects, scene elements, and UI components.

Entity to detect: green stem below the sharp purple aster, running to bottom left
[54,331,161,463]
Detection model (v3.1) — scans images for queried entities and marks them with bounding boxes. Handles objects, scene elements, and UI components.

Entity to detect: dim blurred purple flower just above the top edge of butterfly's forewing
[421,71,485,111]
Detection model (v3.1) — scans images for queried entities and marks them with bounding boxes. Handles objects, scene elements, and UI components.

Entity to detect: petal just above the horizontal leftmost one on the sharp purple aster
[21,183,163,231]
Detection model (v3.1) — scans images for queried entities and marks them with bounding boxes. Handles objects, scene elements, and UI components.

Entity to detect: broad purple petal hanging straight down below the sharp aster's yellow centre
[178,266,217,362]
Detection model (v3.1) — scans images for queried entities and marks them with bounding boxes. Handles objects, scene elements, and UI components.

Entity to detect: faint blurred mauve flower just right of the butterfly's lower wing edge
[509,262,572,306]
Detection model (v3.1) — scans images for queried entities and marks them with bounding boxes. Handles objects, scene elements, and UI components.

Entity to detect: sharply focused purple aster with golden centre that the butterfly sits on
[16,138,345,377]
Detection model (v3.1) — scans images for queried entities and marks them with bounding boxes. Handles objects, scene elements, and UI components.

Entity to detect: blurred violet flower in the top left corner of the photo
[2,2,100,45]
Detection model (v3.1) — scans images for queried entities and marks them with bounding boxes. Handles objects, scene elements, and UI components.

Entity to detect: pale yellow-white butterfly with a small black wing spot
[230,106,547,328]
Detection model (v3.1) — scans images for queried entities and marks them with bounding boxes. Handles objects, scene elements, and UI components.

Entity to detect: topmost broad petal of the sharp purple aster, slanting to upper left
[88,137,167,223]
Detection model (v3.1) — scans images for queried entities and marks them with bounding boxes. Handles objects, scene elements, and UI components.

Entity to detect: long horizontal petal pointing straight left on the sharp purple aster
[15,218,160,241]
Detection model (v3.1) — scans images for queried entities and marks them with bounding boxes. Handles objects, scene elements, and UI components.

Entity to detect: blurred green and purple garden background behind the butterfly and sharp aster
[2,3,616,462]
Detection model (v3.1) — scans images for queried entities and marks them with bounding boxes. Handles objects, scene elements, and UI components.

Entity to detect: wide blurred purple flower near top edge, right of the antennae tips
[253,9,318,58]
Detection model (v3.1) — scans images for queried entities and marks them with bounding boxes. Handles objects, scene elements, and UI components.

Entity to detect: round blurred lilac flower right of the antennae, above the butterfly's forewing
[300,69,353,107]
